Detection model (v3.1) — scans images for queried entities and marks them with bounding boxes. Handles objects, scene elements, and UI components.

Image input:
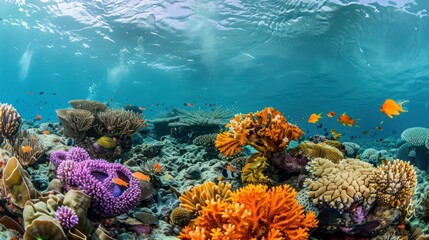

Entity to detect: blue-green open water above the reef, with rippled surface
[0,0,429,137]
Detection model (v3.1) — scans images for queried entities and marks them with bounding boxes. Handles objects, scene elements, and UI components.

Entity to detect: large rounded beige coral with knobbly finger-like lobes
[305,158,376,211]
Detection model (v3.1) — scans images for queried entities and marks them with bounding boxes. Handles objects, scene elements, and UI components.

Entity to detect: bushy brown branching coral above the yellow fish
[94,109,146,137]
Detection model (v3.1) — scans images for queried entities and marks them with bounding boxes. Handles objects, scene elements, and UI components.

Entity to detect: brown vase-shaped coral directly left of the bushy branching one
[55,109,95,142]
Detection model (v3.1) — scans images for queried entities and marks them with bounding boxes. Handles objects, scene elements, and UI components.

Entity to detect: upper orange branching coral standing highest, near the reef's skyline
[216,107,304,156]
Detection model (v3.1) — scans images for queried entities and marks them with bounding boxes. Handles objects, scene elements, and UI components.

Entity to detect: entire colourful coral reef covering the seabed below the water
[0,100,429,240]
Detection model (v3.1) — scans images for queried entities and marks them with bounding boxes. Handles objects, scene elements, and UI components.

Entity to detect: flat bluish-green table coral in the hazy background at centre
[168,107,233,127]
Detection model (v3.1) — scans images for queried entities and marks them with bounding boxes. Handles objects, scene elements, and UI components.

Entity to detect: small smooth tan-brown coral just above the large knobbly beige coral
[298,141,344,163]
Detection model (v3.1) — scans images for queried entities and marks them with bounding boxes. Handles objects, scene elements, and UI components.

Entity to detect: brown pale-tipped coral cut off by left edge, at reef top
[0,103,21,141]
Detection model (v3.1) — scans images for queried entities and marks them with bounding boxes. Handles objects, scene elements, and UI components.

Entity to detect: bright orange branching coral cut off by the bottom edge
[179,184,317,240]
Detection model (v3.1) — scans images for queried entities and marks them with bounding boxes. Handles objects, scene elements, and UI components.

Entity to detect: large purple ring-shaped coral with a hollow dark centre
[67,160,141,220]
